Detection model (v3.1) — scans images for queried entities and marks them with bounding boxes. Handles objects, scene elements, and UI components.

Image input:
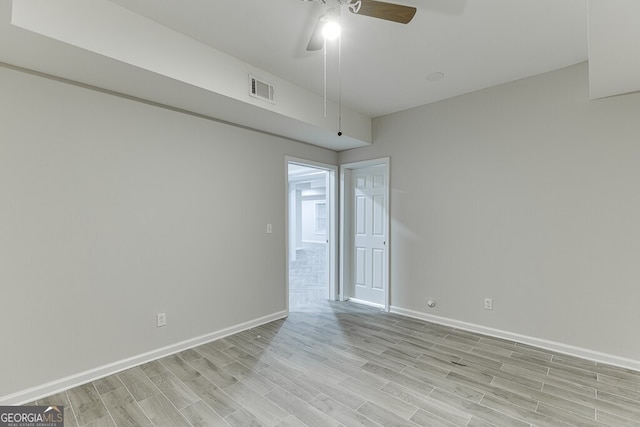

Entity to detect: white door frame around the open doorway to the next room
[284,156,339,313]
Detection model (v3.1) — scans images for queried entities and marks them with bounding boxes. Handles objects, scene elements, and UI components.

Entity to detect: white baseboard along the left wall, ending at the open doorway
[0,311,288,406]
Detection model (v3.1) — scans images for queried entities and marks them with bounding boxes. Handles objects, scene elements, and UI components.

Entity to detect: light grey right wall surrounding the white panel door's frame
[339,64,640,366]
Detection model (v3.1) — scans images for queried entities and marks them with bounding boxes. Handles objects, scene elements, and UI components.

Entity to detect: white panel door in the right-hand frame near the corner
[350,166,387,306]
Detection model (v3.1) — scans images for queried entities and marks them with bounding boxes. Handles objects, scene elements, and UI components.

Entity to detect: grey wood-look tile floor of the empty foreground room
[27,302,640,427]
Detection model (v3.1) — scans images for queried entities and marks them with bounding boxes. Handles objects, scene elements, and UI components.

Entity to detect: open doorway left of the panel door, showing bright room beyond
[287,159,337,311]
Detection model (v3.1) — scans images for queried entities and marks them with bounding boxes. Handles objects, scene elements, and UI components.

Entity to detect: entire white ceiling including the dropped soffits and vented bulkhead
[13,0,640,151]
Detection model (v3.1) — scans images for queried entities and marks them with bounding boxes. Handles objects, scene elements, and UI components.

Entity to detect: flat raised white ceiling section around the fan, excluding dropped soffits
[106,0,587,117]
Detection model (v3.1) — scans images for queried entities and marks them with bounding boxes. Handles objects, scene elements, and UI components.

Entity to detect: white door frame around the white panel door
[339,157,391,312]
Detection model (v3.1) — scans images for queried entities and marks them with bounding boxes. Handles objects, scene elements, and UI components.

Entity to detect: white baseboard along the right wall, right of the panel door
[391,306,640,371]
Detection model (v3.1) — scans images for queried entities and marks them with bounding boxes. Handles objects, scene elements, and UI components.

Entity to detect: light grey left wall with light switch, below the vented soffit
[0,67,337,400]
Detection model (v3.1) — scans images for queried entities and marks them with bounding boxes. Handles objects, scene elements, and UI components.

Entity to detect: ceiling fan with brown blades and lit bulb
[302,0,417,51]
